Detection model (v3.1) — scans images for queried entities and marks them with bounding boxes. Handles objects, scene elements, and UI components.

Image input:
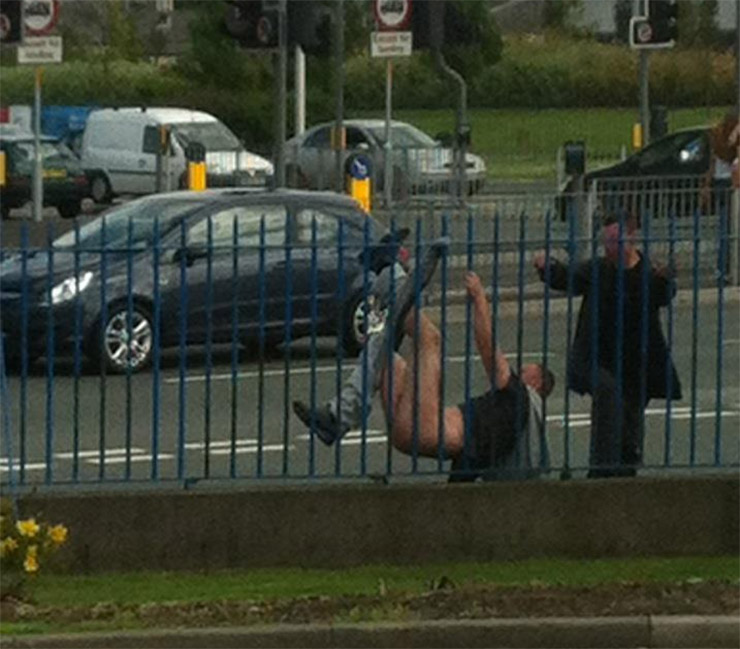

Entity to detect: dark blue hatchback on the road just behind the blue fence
[0,189,394,372]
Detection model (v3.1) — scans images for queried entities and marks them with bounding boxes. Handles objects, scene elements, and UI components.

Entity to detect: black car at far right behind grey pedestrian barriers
[561,127,731,217]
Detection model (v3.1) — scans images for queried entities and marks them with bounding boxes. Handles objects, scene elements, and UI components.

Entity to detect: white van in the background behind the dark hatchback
[80,108,273,203]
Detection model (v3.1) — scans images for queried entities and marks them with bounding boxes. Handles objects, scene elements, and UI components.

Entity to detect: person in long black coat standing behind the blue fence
[534,217,681,478]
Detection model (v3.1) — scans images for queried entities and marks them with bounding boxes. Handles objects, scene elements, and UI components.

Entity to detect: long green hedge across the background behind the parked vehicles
[0,35,736,152]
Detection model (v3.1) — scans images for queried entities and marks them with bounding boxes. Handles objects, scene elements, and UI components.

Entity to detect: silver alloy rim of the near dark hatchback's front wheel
[104,307,154,372]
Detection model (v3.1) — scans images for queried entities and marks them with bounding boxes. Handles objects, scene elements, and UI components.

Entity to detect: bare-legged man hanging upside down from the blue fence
[293,248,555,481]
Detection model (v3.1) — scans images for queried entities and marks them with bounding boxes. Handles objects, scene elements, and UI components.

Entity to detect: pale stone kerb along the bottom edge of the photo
[2,615,740,649]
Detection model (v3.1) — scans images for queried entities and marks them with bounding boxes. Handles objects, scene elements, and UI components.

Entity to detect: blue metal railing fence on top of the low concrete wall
[0,189,740,488]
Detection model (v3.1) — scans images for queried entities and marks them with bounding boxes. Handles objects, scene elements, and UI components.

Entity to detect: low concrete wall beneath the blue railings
[13,477,740,572]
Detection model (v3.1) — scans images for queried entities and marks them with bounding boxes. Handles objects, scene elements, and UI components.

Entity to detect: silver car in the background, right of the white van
[285,119,486,198]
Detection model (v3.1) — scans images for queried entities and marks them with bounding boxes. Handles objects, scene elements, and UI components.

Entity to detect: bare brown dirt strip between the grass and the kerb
[2,582,740,627]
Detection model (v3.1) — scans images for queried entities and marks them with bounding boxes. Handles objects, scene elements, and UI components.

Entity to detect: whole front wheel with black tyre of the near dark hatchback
[91,302,154,374]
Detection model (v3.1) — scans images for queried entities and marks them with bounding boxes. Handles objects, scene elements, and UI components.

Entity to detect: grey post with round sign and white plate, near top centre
[370,0,412,208]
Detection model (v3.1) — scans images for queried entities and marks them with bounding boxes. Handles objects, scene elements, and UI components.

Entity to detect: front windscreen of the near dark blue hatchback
[54,198,206,251]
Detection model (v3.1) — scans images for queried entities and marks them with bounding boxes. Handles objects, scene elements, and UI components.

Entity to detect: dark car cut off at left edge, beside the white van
[0,125,89,218]
